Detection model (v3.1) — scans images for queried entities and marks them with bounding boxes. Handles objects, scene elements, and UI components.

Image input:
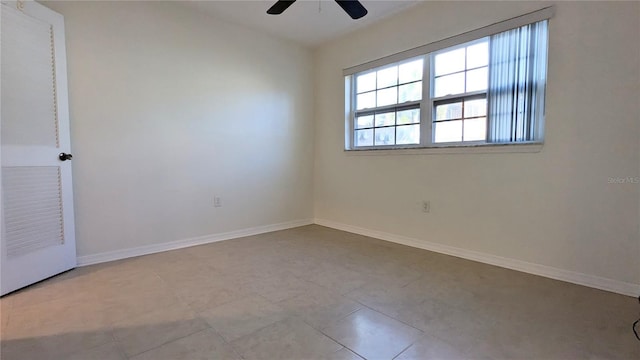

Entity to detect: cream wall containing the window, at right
[314,2,640,284]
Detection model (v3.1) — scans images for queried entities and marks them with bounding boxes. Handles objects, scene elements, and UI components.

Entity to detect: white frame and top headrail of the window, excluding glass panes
[343,6,555,152]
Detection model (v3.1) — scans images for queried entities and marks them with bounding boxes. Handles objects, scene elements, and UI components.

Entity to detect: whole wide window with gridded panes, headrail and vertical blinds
[345,9,550,150]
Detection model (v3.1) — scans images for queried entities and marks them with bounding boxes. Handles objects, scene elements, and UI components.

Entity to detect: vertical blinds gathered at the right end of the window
[487,21,547,143]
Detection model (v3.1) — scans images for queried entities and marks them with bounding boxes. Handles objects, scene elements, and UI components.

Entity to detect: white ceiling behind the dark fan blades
[185,0,420,47]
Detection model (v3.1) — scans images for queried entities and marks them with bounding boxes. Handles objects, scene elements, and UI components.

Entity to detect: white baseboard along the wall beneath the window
[314,219,640,297]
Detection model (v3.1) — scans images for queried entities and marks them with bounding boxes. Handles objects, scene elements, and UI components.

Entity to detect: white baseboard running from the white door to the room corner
[78,219,313,266]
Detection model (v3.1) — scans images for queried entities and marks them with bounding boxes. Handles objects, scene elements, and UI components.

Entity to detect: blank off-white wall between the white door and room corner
[45,1,313,256]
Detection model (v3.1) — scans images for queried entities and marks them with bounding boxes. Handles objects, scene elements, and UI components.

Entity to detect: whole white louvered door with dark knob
[0,0,76,295]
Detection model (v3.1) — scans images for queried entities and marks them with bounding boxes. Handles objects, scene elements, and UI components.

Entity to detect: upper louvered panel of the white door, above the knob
[0,6,59,147]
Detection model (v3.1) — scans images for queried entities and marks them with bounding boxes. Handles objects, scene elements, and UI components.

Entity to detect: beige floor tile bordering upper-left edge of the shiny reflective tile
[278,289,362,329]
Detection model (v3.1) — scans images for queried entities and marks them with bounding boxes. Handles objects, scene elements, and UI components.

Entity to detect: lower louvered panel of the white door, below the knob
[2,166,64,258]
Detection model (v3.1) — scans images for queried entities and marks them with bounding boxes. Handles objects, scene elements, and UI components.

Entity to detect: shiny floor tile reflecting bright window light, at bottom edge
[323,309,422,359]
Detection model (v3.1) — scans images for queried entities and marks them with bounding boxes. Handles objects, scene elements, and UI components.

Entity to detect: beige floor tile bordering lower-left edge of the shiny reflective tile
[231,319,342,360]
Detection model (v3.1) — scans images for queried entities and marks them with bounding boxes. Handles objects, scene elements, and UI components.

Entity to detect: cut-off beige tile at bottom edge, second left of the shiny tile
[131,329,240,360]
